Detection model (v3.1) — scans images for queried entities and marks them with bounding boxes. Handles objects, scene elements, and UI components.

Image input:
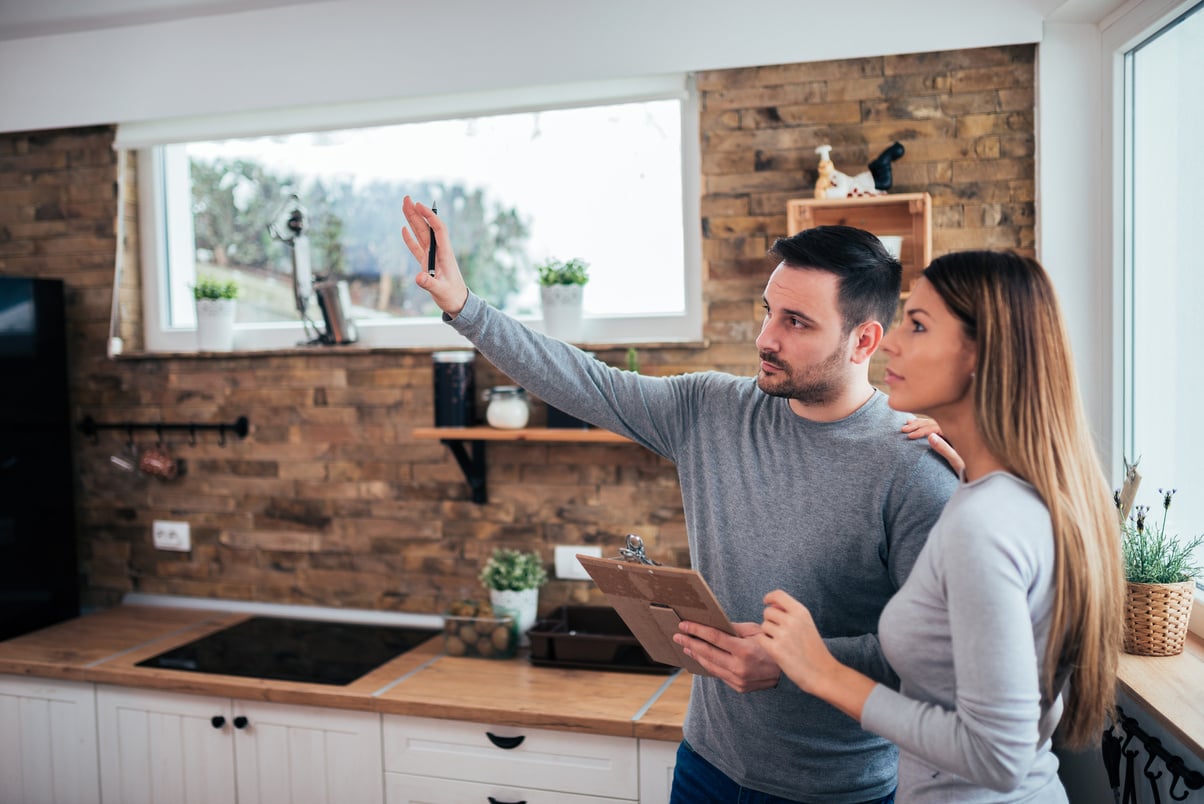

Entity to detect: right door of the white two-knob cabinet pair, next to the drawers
[234,700,384,804]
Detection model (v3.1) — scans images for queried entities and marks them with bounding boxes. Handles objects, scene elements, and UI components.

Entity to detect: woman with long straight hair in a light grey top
[760,252,1123,803]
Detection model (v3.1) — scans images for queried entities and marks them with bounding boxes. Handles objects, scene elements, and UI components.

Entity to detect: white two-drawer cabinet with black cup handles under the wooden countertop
[383,715,639,804]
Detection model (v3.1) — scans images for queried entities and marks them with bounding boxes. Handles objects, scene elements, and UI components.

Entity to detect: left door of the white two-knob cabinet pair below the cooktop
[96,686,235,804]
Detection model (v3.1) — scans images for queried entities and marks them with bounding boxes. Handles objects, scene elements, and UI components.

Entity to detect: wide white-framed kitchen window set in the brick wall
[117,76,702,351]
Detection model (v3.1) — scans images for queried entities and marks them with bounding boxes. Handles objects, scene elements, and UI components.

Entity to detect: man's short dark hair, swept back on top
[769,226,903,333]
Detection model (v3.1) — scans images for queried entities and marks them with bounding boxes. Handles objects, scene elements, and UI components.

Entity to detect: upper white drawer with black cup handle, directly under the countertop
[384,715,639,800]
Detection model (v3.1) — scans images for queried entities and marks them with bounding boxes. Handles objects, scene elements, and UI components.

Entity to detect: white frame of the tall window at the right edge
[1099,0,1204,637]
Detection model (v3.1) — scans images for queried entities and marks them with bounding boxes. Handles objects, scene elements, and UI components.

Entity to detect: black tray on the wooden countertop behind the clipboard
[527,605,677,674]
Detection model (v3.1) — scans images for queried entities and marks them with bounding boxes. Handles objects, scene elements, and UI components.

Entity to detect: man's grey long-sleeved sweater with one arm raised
[452,294,956,804]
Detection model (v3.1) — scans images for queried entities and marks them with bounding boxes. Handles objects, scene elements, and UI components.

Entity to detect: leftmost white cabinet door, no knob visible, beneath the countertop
[0,675,100,804]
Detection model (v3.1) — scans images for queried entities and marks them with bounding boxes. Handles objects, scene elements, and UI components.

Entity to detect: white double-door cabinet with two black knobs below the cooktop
[96,686,384,804]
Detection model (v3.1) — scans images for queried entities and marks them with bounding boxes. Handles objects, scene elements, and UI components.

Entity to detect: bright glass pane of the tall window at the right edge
[1122,2,1204,584]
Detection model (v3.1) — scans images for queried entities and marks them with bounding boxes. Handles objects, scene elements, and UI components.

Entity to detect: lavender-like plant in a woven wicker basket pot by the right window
[1116,464,1204,656]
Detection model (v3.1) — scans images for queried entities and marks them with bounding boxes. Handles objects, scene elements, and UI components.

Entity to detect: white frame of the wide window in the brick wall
[116,75,703,353]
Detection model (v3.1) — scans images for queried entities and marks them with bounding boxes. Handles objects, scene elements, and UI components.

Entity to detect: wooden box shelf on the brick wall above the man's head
[786,193,932,295]
